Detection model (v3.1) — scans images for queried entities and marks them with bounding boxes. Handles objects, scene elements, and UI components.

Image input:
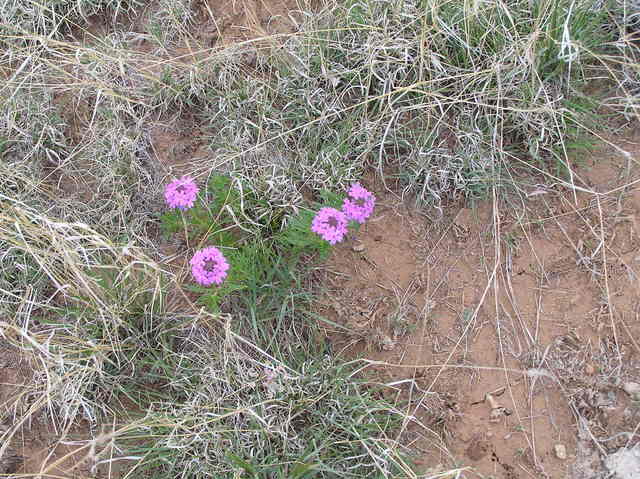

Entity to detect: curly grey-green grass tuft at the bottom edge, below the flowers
[119,342,405,479]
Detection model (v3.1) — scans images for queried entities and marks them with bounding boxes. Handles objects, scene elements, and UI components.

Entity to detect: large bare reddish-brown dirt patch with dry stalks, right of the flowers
[323,132,640,479]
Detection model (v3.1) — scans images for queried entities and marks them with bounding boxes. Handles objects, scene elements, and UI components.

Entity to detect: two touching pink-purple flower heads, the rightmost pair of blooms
[311,183,376,245]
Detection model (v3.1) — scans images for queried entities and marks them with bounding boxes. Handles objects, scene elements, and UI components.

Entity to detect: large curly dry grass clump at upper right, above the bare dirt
[196,0,614,211]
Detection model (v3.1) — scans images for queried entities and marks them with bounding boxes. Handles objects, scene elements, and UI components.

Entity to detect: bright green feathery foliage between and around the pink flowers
[161,175,340,312]
